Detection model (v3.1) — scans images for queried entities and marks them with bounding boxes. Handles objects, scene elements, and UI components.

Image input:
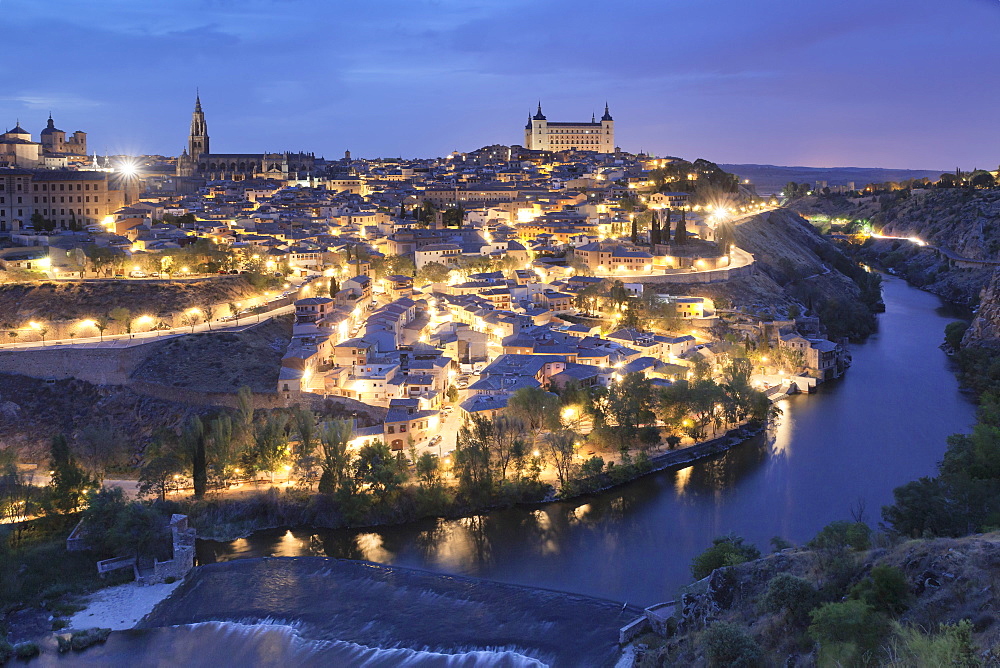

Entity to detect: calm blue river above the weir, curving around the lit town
[198,277,975,605]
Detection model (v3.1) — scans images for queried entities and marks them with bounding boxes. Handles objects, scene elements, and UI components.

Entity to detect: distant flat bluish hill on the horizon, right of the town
[719,165,951,195]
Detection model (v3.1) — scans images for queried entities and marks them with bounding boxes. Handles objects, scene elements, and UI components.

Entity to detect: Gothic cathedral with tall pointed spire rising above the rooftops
[177,95,316,181]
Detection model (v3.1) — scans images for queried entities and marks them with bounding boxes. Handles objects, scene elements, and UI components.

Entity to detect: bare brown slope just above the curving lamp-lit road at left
[0,276,258,328]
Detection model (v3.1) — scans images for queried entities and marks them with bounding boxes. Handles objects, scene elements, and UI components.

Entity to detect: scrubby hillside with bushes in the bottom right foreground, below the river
[635,523,1000,667]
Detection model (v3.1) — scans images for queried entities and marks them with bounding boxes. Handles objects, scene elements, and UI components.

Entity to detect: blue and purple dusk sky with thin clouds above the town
[0,0,1000,170]
